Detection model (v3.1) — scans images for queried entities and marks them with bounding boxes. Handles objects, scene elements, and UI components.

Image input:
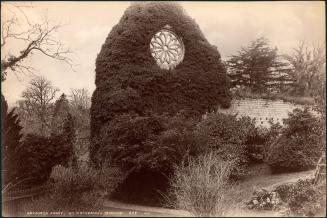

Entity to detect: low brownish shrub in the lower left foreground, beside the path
[20,165,123,215]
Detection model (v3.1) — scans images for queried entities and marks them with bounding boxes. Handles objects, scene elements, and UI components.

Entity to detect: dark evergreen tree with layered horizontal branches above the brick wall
[227,38,290,92]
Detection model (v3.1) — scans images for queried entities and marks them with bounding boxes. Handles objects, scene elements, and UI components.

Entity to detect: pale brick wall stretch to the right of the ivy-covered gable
[218,98,310,127]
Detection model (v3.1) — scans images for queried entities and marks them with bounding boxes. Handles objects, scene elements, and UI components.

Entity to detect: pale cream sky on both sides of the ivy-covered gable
[1,1,325,105]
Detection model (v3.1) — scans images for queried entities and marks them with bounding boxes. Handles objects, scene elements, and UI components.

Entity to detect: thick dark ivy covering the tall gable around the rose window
[90,2,230,167]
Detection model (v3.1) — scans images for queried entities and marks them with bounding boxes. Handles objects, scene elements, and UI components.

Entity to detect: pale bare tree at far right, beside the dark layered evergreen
[285,41,326,96]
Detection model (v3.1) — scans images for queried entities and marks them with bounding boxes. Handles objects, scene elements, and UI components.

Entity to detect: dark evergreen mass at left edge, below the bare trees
[1,92,74,187]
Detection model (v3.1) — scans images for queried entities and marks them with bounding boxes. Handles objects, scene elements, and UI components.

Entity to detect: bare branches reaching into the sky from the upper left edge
[1,3,72,81]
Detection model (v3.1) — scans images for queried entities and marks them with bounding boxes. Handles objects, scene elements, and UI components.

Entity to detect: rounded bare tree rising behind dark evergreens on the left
[20,76,59,136]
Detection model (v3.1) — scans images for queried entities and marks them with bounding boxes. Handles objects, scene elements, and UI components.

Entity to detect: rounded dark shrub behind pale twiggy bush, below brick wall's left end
[195,113,255,178]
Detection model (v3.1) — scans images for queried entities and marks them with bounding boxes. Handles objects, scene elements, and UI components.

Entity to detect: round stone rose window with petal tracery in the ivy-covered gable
[150,25,184,70]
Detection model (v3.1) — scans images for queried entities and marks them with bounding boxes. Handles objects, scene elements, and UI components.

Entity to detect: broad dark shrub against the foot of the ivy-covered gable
[95,114,197,173]
